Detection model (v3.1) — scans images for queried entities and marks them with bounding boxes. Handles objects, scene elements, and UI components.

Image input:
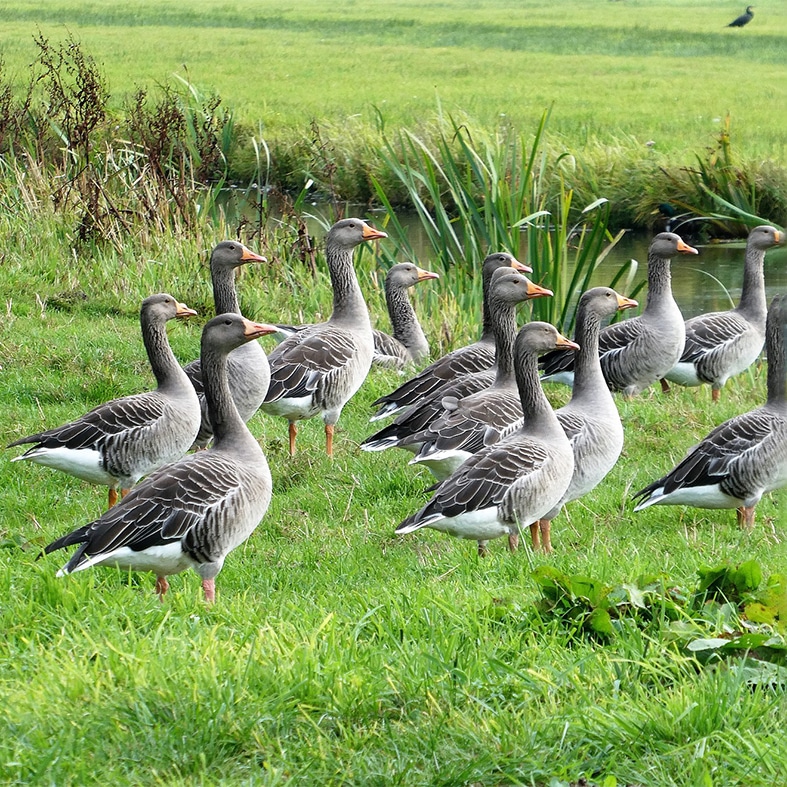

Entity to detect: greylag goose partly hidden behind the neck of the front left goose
[186,240,271,448]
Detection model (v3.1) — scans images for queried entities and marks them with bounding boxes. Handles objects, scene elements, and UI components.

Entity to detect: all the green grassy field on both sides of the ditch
[0,0,787,787]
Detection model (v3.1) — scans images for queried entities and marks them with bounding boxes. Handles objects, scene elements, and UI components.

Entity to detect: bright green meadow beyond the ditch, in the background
[0,0,787,160]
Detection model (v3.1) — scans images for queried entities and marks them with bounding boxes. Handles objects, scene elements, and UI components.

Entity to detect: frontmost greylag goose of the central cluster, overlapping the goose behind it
[396,322,577,555]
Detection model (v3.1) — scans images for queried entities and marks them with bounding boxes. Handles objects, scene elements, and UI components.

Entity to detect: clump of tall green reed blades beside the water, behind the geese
[373,112,630,332]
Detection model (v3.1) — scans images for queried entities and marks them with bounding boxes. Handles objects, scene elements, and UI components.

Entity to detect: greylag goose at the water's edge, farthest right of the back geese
[662,224,784,402]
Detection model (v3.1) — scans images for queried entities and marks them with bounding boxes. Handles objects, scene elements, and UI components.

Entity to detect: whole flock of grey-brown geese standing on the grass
[11,218,787,602]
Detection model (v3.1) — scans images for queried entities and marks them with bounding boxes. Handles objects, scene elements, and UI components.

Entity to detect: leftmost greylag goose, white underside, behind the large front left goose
[9,293,199,508]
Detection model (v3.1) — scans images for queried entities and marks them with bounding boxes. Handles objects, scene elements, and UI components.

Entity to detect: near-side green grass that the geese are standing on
[0,205,787,787]
